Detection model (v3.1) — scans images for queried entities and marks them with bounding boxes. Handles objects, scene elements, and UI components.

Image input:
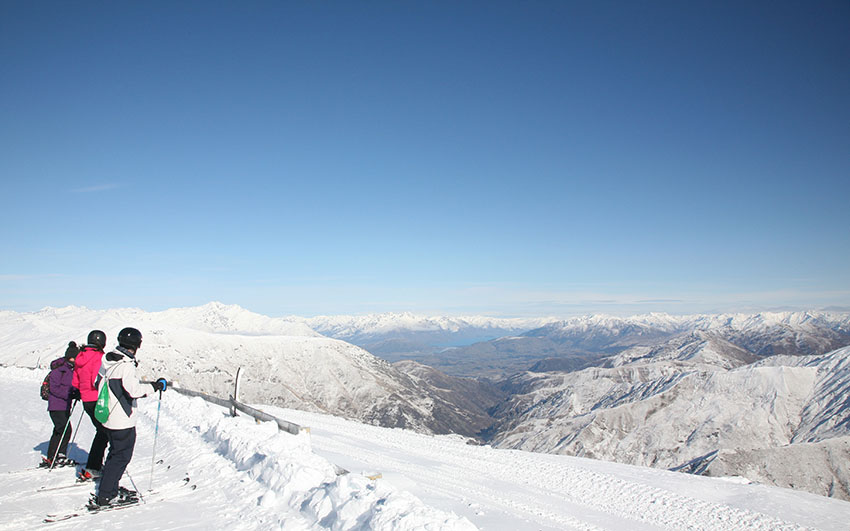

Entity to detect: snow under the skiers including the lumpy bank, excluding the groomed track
[0,368,475,531]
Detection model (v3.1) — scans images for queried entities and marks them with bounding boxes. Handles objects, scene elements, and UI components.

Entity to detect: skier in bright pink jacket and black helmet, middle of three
[72,330,109,481]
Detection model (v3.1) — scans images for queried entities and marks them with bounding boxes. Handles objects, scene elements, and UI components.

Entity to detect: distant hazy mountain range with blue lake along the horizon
[308,312,850,379]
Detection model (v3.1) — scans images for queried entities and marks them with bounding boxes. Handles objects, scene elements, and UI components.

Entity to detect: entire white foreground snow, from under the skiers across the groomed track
[0,368,850,531]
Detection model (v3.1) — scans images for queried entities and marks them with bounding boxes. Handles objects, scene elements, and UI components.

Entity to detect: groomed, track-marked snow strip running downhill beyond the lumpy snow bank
[263,406,832,531]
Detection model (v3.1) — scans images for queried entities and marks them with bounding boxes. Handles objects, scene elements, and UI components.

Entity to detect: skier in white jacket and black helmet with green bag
[89,328,166,510]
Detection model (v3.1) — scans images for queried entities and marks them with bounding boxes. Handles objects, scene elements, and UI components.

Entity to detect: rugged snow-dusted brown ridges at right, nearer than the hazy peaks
[486,344,850,499]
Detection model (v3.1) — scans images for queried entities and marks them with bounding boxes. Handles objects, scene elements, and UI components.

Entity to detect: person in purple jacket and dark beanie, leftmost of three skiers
[39,341,79,468]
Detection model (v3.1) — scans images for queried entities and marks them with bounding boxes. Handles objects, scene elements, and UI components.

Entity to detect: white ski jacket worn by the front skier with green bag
[97,347,150,430]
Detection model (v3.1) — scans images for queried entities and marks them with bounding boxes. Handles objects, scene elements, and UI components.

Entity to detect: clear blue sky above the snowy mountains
[0,0,850,316]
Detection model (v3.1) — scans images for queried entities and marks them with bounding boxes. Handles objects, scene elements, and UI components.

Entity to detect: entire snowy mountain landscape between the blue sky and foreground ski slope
[0,303,850,499]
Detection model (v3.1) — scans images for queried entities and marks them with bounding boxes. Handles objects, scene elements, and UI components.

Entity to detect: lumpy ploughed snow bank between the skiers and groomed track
[163,395,475,530]
